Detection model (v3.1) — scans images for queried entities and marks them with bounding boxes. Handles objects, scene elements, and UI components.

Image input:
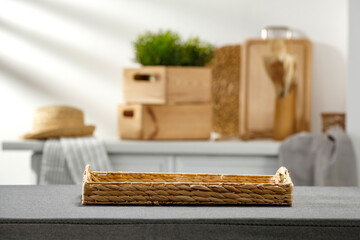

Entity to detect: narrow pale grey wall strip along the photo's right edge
[346,0,360,185]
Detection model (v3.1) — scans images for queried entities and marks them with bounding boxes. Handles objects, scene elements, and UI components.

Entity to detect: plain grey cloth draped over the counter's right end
[279,127,358,186]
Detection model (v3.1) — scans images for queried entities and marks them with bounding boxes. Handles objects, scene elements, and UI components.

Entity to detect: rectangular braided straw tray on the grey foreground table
[82,165,294,205]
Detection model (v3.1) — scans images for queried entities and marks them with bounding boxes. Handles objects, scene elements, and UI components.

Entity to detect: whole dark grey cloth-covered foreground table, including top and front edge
[0,186,360,240]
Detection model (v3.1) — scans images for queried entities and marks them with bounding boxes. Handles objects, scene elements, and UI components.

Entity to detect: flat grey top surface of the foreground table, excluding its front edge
[0,186,360,221]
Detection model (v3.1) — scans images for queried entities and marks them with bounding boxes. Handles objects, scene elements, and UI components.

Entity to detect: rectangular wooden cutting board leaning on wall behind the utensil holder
[239,39,312,140]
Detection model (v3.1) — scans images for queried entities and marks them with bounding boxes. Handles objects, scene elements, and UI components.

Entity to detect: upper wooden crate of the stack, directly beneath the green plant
[123,66,211,104]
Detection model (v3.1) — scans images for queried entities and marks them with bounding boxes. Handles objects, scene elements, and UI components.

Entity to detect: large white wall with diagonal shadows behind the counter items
[0,0,348,184]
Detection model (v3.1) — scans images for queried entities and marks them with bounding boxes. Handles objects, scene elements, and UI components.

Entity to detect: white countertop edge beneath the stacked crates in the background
[2,140,281,156]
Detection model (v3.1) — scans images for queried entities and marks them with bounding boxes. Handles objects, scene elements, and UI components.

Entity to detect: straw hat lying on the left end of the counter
[23,106,95,139]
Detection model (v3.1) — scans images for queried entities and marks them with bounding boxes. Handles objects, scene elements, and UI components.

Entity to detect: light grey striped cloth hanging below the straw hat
[39,137,112,185]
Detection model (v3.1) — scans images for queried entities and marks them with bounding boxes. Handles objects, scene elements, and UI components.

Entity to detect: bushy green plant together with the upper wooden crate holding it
[123,31,214,104]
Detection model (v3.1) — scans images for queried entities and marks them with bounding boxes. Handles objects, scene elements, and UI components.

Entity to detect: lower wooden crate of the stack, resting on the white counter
[118,104,212,140]
